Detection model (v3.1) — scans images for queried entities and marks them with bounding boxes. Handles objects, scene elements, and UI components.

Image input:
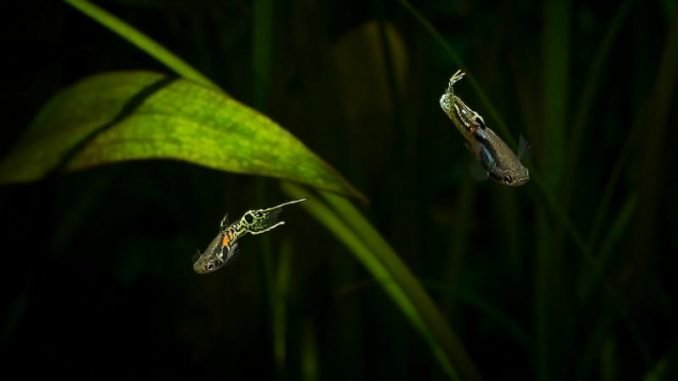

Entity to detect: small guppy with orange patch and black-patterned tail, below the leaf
[193,198,306,274]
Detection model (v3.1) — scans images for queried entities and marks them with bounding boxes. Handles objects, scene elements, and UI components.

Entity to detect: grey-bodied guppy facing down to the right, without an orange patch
[440,70,530,186]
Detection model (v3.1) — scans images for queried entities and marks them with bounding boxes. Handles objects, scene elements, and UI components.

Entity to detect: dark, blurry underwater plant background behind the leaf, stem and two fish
[0,0,678,380]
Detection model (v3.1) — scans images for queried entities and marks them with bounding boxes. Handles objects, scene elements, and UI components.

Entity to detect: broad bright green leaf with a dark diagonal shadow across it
[0,71,362,198]
